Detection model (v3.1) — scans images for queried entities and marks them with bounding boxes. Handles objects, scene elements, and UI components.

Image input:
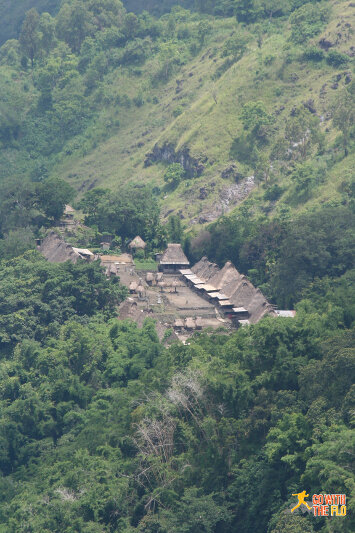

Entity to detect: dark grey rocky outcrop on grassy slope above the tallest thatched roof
[144,143,207,178]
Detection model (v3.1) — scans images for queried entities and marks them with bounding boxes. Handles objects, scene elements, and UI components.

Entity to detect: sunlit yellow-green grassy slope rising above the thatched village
[1,1,355,231]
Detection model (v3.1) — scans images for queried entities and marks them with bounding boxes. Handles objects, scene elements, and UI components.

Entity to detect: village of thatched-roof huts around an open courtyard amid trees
[37,206,295,342]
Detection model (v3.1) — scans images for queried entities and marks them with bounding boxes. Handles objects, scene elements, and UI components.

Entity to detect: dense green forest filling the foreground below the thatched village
[0,252,355,533]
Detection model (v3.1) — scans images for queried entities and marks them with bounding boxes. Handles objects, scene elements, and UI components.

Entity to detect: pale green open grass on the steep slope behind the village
[53,2,354,225]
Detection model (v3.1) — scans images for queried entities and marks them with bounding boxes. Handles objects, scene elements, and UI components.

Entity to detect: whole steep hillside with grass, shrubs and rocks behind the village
[1,2,355,231]
